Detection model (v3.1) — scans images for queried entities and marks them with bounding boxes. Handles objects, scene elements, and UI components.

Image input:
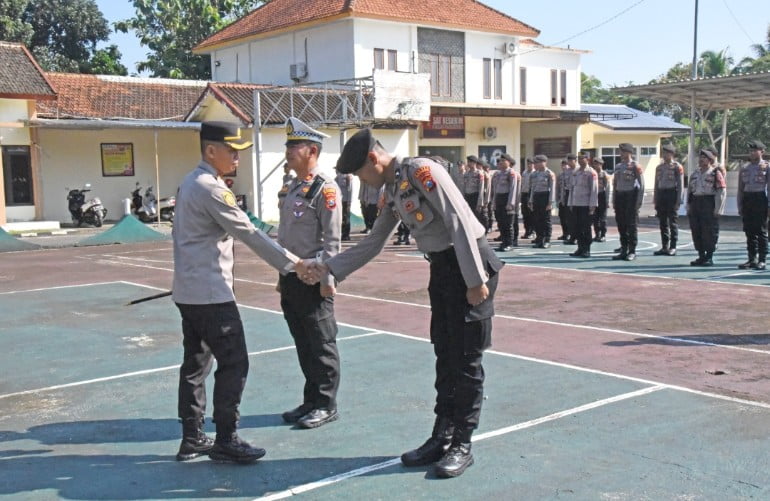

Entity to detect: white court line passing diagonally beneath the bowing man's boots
[254,386,664,501]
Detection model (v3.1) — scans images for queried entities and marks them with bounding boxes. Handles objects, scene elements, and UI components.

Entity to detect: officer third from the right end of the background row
[653,143,684,256]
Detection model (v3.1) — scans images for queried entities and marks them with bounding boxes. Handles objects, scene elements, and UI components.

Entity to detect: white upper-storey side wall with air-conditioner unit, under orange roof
[211,19,354,85]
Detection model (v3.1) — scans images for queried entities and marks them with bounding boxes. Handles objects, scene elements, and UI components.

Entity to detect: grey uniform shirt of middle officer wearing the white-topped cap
[278,168,342,285]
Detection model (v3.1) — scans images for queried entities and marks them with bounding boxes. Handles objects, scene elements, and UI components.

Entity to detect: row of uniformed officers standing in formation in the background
[455,140,770,270]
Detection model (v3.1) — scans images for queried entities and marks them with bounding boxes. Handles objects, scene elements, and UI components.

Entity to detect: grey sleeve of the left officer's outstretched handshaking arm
[202,187,299,274]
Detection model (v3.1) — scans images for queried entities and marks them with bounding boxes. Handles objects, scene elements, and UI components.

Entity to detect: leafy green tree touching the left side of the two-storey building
[115,0,264,79]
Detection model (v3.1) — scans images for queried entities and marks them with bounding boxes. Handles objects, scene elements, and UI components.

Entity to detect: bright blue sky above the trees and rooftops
[96,0,770,86]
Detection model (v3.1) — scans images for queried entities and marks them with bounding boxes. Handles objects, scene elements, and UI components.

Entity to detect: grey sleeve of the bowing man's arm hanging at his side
[412,162,489,288]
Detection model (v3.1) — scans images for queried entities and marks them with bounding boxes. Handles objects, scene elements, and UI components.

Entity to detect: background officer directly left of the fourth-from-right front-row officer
[568,153,599,257]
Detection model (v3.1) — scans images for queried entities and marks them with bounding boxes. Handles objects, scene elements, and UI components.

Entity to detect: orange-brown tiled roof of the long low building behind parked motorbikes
[37,73,208,120]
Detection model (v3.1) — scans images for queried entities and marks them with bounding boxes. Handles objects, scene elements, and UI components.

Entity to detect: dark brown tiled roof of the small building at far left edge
[0,42,56,100]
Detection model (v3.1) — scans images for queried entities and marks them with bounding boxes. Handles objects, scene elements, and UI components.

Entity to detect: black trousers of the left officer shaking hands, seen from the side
[176,302,249,434]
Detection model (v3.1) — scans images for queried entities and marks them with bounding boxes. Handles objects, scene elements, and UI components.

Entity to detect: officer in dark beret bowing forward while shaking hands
[306,129,503,477]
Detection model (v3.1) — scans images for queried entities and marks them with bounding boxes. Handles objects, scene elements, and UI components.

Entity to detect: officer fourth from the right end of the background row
[612,143,644,261]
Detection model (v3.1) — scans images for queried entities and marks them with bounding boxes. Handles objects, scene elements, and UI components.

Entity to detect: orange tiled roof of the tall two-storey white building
[195,0,540,51]
